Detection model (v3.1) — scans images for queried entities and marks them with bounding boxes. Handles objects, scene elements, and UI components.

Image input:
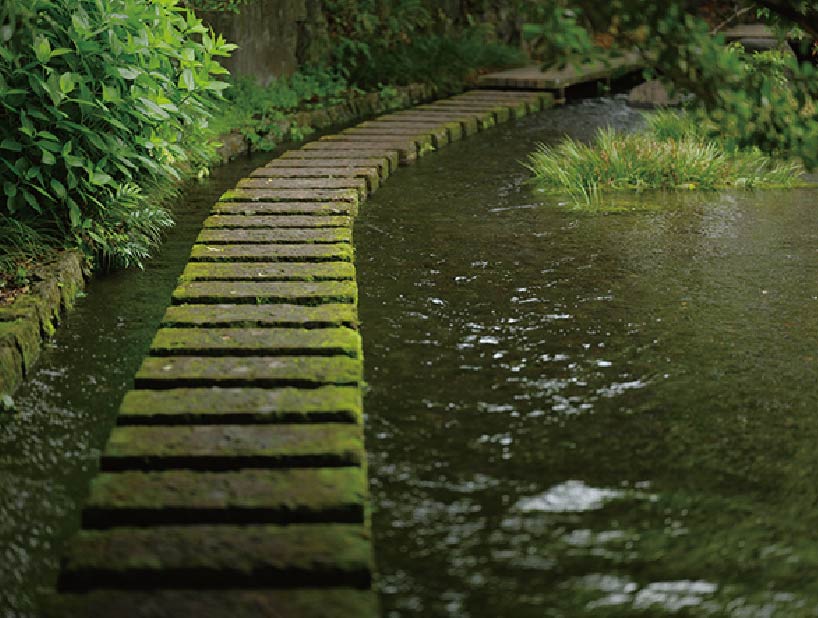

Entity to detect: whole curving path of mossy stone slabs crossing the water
[44,91,553,618]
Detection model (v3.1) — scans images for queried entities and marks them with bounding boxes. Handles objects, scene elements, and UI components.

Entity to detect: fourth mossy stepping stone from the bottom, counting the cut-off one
[100,423,364,472]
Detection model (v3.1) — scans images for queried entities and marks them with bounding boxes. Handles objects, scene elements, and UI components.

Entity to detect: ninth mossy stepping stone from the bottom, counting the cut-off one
[173,281,358,305]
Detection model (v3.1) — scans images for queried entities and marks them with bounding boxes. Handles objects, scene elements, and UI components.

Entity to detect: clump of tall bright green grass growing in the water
[527,112,804,204]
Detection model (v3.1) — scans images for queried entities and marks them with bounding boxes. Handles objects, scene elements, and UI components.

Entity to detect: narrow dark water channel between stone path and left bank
[0,148,272,618]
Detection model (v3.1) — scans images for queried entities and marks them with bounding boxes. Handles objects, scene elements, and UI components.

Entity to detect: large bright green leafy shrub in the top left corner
[0,0,233,265]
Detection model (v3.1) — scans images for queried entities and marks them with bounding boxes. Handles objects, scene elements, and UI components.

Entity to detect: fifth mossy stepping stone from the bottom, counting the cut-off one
[117,386,362,425]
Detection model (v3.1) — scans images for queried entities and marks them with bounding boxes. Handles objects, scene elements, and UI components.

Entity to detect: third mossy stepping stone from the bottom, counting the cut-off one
[82,467,367,529]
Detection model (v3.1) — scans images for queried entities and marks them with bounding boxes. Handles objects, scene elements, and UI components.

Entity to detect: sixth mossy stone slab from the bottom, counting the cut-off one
[136,356,362,389]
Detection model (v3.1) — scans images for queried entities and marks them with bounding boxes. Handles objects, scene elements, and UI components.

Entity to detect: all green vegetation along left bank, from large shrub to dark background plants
[0,0,521,287]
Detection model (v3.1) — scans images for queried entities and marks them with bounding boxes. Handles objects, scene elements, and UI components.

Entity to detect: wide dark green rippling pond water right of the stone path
[356,101,818,618]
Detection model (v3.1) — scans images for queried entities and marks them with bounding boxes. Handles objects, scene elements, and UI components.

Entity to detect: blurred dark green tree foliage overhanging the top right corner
[528,0,818,167]
